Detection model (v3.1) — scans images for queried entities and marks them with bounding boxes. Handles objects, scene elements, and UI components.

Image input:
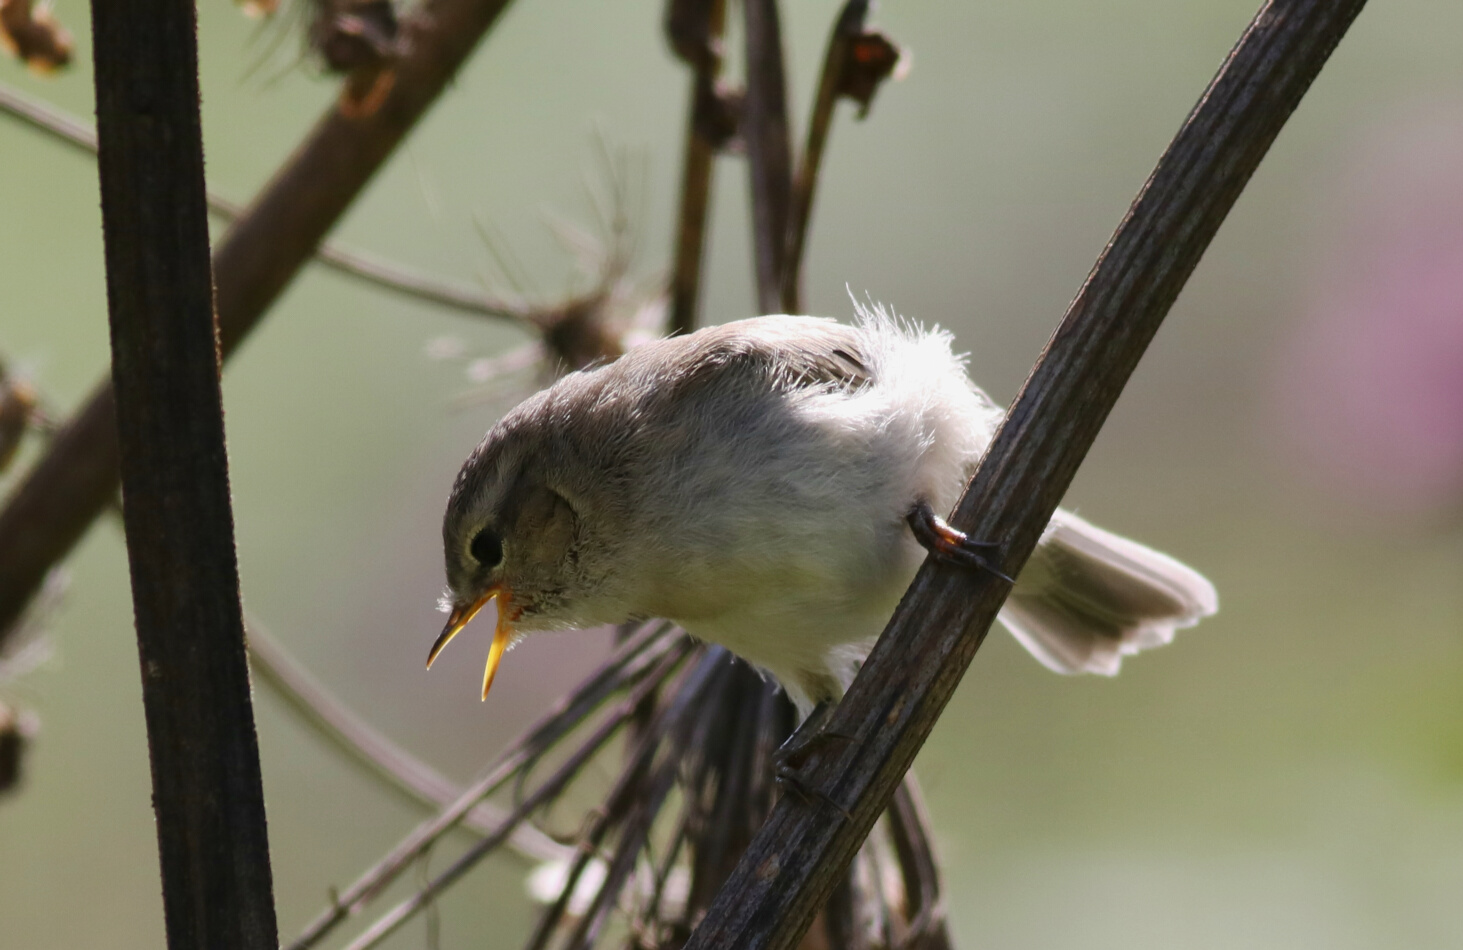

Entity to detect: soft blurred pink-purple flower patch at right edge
[1276,104,1463,523]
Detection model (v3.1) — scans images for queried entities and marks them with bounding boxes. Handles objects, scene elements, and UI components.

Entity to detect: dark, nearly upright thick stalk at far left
[92,0,278,950]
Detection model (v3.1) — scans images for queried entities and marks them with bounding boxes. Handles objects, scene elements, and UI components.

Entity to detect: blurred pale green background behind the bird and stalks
[0,0,1463,950]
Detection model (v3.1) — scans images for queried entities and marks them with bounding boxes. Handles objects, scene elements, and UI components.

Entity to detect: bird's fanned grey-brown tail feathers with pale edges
[1001,511,1219,676]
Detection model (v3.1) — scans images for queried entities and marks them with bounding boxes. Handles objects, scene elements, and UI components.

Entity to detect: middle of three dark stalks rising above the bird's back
[742,0,793,313]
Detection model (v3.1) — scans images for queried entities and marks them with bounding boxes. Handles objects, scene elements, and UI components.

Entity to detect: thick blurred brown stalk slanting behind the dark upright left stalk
[0,0,520,641]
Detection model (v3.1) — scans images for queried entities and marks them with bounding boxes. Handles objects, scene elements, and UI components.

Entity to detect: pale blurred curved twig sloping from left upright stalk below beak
[244,612,569,861]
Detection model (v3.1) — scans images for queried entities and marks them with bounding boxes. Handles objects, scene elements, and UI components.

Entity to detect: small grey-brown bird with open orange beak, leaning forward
[427,307,1219,716]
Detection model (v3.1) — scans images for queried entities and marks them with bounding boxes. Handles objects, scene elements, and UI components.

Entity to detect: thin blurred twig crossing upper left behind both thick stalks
[0,83,534,326]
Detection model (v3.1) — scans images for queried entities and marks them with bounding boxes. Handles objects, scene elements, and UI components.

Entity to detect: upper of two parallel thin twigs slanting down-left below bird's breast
[290,624,685,950]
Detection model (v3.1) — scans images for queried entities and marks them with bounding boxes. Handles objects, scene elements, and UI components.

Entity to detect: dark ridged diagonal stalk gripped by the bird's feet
[688,0,1364,950]
